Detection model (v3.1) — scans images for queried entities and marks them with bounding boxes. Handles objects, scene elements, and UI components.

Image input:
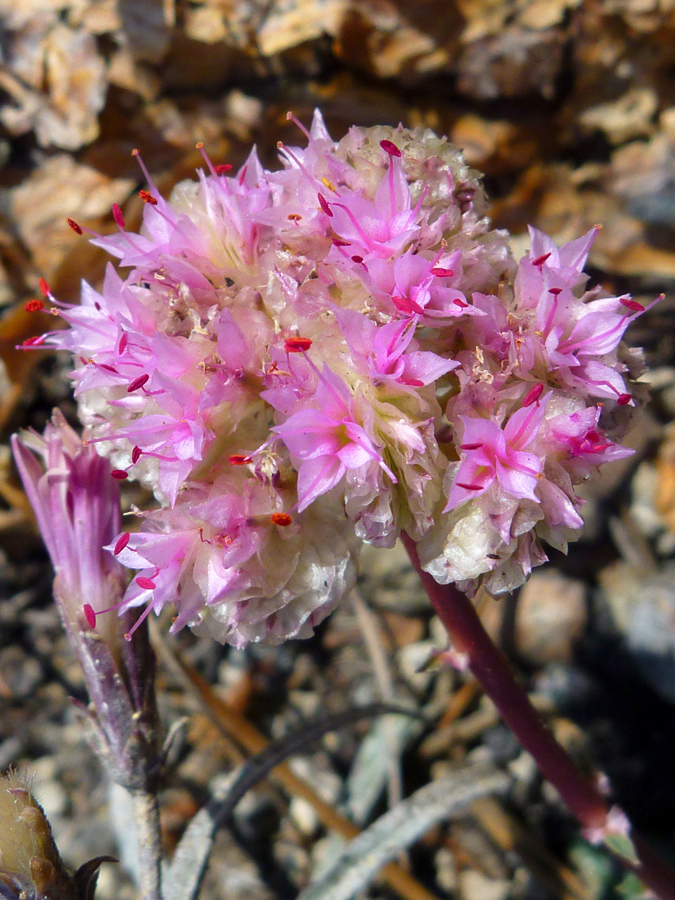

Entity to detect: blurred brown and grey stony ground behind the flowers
[0,0,675,900]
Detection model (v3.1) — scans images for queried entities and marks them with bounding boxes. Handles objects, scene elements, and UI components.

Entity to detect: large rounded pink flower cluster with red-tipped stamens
[23,113,643,645]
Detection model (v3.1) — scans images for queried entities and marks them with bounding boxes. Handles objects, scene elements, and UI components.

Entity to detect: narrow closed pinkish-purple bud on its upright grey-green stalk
[12,418,159,900]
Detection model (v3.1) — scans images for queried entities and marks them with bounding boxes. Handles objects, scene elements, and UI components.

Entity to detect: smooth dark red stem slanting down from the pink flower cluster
[402,534,675,900]
